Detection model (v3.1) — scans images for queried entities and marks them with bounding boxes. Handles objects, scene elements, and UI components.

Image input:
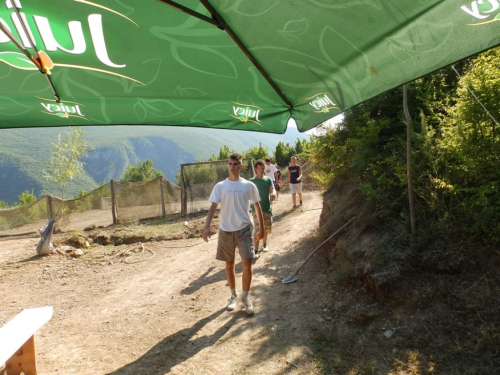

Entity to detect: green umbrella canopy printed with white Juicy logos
[0,0,500,133]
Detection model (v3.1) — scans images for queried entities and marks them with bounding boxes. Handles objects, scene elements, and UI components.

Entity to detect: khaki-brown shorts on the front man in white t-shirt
[215,225,255,262]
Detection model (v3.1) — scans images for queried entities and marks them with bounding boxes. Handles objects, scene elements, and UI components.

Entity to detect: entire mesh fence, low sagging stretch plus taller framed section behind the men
[0,158,254,236]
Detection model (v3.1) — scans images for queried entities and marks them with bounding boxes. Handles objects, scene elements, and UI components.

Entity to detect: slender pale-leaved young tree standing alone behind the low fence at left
[43,126,94,210]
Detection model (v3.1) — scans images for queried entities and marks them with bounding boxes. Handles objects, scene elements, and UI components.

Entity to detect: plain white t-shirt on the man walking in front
[209,178,260,232]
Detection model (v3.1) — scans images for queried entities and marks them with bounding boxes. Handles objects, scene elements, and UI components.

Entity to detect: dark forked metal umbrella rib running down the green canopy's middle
[158,0,293,110]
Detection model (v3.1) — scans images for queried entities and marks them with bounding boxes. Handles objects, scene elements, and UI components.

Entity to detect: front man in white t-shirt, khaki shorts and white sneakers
[202,153,264,315]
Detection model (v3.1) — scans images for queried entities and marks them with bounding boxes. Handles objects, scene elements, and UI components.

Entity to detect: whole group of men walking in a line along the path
[202,153,302,315]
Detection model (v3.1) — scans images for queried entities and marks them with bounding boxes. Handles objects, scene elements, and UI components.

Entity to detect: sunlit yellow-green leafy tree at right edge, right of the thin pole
[436,48,500,241]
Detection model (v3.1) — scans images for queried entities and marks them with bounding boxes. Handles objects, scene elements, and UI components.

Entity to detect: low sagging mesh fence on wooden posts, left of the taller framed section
[0,176,182,236]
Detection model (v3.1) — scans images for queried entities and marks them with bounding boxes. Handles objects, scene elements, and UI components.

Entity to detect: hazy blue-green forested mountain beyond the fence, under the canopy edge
[0,126,309,204]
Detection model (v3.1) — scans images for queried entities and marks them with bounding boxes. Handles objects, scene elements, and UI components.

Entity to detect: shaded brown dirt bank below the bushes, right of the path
[317,183,500,375]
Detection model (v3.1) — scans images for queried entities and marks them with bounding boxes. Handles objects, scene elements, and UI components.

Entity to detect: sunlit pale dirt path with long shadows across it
[0,193,328,375]
